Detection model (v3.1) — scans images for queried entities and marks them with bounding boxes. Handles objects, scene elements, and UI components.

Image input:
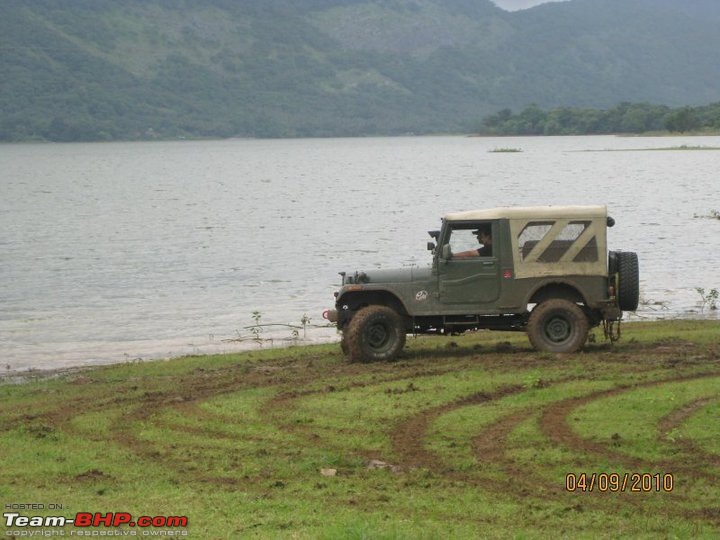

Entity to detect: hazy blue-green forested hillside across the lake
[0,0,720,141]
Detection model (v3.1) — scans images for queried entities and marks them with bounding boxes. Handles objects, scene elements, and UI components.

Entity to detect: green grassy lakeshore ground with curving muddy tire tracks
[0,321,720,539]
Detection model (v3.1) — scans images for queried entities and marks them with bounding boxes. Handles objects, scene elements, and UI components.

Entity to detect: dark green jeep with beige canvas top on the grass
[323,206,639,361]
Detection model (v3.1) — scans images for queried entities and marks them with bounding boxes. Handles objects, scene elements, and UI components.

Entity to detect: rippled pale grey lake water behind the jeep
[0,137,720,372]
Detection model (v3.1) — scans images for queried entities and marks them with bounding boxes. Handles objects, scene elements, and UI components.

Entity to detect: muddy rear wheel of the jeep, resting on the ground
[527,299,589,353]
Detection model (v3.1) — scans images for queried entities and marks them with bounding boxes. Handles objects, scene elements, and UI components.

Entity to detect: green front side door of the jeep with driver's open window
[438,222,500,311]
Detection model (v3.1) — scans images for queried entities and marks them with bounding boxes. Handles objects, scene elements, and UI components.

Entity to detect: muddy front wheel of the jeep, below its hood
[344,306,405,362]
